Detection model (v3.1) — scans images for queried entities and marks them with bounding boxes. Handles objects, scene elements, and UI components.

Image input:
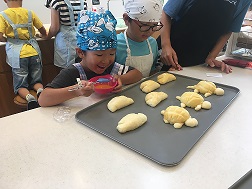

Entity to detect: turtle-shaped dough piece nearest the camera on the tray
[161,106,198,129]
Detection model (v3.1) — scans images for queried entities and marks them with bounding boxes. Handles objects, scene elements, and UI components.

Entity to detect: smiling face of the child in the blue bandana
[81,49,116,74]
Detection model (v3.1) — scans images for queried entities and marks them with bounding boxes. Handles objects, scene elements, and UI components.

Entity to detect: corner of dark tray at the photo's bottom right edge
[229,169,252,189]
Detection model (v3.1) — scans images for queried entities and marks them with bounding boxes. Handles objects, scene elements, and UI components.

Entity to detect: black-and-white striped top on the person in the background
[45,0,87,26]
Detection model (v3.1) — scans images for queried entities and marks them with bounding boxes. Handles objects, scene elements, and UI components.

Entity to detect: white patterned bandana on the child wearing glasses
[124,0,163,22]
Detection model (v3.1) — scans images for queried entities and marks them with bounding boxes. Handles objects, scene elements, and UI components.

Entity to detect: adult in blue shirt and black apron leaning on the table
[161,0,251,73]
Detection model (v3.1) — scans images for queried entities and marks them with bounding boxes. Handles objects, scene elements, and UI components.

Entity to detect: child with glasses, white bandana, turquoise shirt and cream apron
[116,0,163,77]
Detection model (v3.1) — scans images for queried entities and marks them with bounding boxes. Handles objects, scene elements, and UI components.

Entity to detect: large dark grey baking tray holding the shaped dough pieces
[75,72,240,166]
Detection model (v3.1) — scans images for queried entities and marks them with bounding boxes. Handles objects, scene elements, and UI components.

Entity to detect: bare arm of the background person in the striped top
[47,8,60,39]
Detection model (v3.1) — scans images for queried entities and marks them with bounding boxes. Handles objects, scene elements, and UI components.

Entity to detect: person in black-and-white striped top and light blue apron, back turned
[45,0,87,68]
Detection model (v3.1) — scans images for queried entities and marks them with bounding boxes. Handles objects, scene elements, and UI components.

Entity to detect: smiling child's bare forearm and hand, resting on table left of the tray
[38,80,94,107]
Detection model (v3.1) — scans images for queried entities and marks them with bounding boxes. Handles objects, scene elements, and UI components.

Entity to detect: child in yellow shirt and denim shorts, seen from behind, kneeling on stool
[0,0,46,109]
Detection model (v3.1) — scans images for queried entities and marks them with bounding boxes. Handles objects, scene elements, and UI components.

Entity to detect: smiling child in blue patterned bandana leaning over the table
[38,9,142,106]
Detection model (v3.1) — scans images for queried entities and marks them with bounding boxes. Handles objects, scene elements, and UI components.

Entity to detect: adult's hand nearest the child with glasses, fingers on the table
[160,46,182,70]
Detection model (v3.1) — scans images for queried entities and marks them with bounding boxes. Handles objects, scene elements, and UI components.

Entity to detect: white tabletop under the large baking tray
[0,62,252,189]
